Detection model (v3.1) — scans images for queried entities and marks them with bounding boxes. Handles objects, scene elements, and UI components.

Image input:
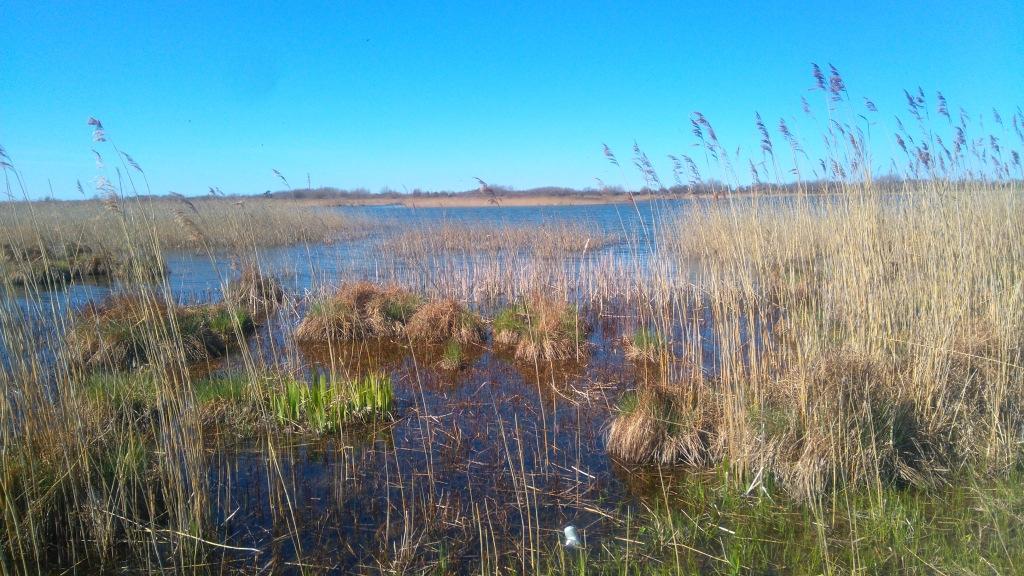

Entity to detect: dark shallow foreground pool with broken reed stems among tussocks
[197,317,633,569]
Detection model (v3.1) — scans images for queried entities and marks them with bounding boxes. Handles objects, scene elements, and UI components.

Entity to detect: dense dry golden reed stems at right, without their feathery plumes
[634,182,1024,497]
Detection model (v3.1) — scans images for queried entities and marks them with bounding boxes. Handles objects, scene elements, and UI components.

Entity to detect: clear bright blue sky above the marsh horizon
[0,0,1024,198]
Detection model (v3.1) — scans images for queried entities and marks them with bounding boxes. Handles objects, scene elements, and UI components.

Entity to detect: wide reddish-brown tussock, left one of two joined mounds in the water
[295,282,421,344]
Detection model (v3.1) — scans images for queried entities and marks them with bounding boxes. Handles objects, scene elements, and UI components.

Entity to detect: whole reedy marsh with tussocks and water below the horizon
[0,73,1024,574]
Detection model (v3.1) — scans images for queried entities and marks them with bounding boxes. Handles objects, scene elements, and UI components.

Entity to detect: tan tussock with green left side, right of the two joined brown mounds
[493,294,588,362]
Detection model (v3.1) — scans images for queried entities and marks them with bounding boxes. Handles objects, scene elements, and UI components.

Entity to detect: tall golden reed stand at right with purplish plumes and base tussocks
[606,66,1024,499]
